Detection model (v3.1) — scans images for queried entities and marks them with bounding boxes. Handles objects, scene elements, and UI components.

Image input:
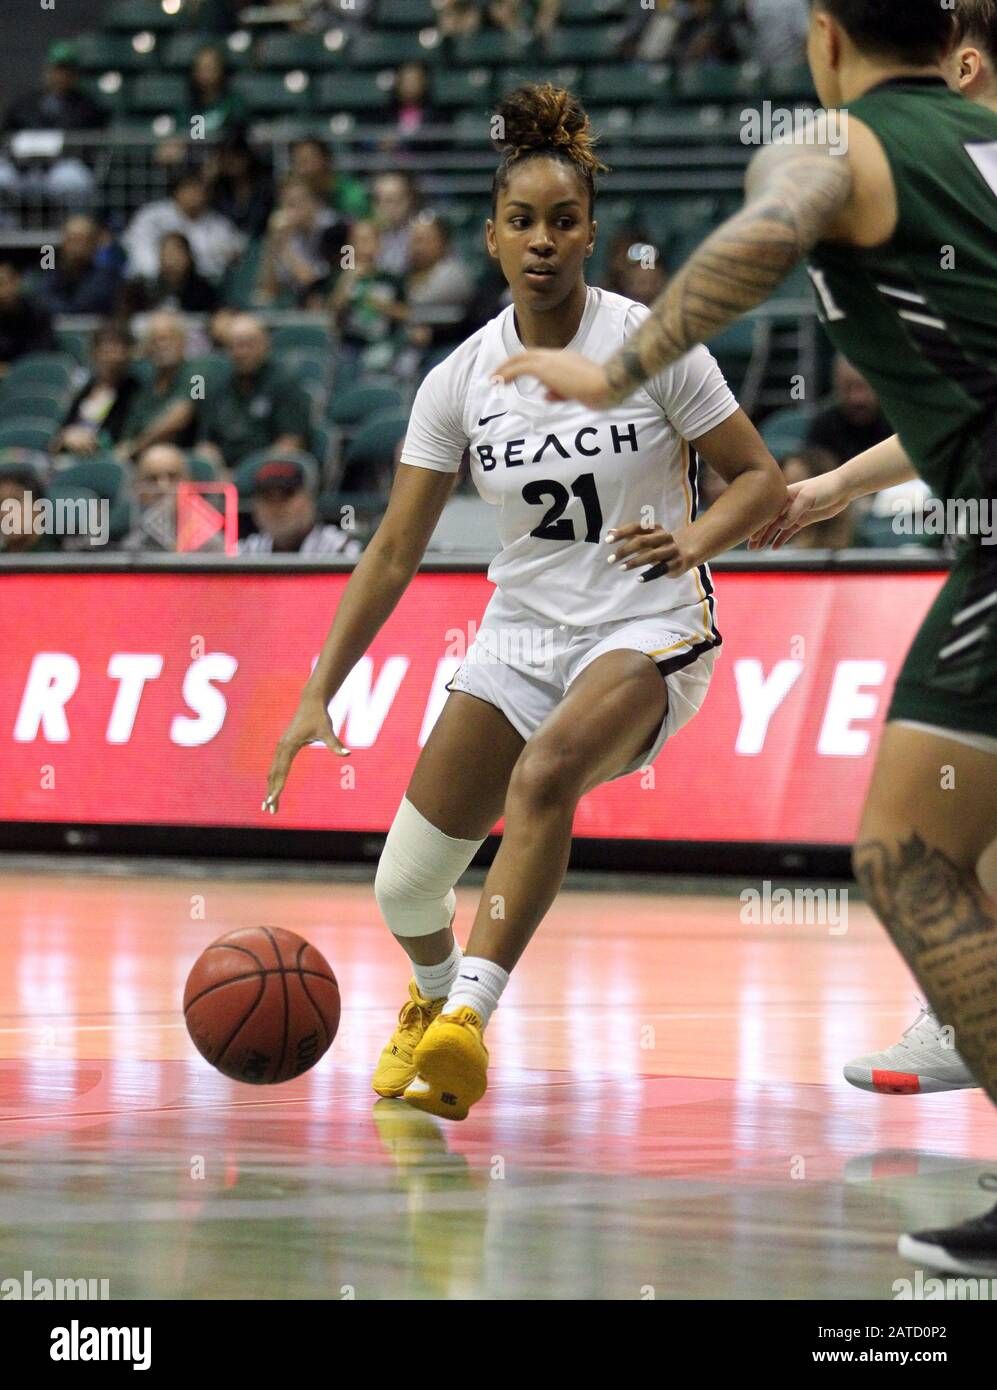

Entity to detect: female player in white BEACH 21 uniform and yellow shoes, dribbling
[264,85,787,1119]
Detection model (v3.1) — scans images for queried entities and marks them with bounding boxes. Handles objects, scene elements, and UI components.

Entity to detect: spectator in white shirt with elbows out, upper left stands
[124,172,246,281]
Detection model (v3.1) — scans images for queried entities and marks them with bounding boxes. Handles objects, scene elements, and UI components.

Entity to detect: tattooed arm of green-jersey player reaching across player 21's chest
[606,146,852,403]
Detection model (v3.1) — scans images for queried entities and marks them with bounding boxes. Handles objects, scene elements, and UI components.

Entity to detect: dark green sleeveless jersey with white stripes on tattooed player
[809,78,997,498]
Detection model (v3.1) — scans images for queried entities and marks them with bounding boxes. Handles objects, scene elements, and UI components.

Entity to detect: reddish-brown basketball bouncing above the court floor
[184,927,339,1086]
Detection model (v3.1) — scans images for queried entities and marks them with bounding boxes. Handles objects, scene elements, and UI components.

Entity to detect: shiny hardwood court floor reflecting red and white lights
[0,859,997,1300]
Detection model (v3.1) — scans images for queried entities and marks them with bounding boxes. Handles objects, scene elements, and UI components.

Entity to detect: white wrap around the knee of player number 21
[374,796,484,937]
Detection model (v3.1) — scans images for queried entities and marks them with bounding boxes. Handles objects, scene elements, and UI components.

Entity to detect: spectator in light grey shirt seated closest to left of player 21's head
[394,213,474,349]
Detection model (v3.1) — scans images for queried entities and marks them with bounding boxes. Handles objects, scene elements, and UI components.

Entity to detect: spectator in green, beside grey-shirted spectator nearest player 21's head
[330,218,405,371]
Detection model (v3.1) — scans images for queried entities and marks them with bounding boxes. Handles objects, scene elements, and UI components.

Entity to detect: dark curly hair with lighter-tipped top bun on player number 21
[492,82,609,217]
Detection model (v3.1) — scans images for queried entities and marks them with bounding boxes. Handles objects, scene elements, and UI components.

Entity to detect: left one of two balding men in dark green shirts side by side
[114,311,203,460]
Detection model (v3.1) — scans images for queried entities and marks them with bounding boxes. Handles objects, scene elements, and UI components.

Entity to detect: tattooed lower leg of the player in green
[855,834,997,1099]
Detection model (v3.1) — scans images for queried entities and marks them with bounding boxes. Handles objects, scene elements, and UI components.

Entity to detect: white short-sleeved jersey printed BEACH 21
[402,288,738,641]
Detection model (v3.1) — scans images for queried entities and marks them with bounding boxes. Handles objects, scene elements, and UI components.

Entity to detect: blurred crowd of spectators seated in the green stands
[0,0,912,556]
